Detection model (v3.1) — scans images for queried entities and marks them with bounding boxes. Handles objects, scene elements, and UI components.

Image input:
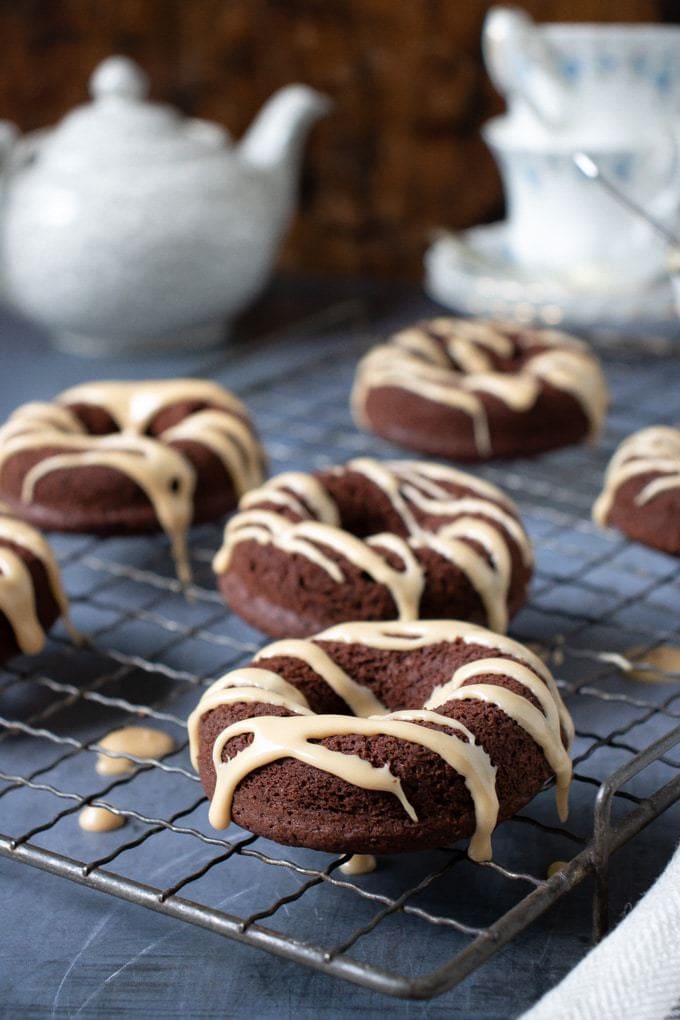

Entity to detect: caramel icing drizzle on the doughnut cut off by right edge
[592,425,680,525]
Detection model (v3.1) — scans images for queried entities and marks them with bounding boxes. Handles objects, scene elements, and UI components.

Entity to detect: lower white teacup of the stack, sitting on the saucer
[482,116,680,286]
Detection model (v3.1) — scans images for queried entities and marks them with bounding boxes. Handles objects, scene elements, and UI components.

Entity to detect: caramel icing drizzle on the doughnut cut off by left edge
[0,504,75,655]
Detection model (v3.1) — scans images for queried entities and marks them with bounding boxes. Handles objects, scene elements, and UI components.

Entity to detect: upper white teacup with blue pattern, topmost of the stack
[482,7,680,144]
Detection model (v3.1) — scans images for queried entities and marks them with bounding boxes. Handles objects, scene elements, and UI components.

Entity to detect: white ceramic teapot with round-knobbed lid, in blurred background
[0,57,329,354]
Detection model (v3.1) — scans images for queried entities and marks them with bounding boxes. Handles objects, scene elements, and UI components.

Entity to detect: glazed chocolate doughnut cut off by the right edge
[592,425,680,556]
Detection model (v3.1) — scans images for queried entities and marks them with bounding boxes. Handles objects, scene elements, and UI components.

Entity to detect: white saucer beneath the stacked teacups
[425,222,680,346]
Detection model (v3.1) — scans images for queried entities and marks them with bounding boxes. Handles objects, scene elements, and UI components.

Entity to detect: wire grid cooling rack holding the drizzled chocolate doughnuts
[0,316,680,998]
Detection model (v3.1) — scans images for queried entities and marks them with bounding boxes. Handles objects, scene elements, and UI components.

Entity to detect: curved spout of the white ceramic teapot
[240,85,330,175]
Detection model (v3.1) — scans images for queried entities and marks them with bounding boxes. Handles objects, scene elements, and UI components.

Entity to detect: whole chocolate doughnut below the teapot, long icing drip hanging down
[0,379,263,580]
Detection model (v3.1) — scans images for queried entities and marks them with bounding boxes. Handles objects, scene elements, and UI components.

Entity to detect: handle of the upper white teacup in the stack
[481,6,570,128]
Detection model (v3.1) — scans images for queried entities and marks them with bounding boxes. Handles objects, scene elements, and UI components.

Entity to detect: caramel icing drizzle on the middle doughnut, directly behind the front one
[213,458,532,631]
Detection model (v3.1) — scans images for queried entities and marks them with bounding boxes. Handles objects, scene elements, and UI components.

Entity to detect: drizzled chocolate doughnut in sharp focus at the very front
[189,620,573,861]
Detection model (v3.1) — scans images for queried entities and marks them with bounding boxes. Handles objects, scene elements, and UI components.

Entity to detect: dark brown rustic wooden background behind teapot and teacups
[0,0,680,278]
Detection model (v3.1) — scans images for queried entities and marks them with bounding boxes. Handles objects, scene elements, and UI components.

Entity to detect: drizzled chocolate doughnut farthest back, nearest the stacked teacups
[352,317,607,461]
